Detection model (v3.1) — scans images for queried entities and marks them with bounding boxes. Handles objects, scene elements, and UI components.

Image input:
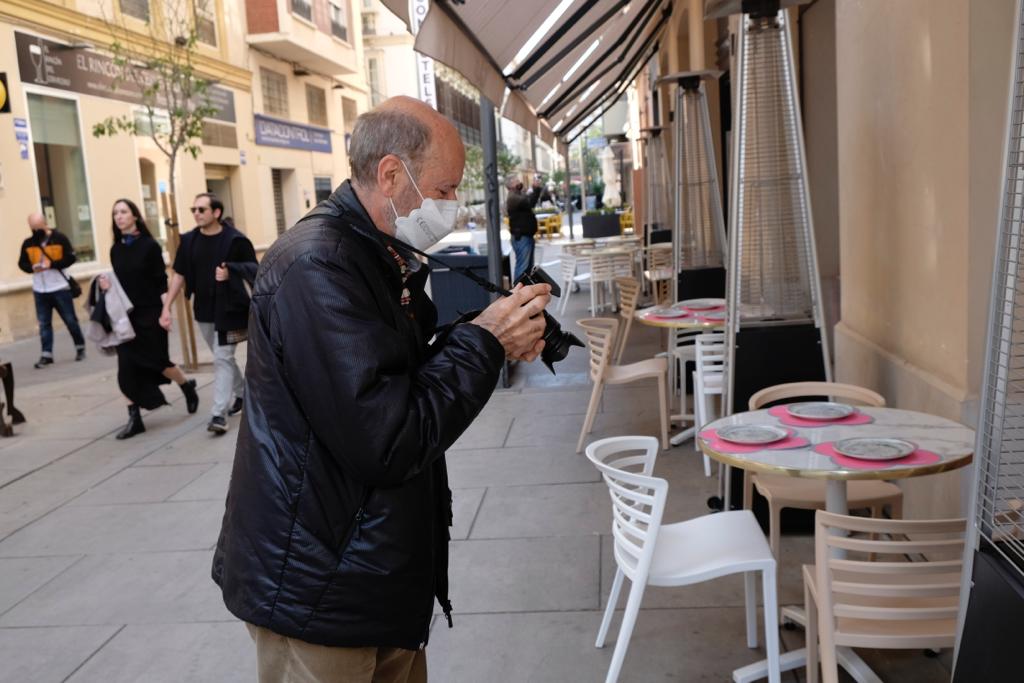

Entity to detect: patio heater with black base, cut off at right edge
[953,2,1024,683]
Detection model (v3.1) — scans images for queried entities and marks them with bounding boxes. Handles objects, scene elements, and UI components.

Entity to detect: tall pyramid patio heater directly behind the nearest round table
[711,0,831,411]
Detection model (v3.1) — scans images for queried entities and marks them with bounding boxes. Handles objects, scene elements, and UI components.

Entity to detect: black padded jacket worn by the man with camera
[213,182,505,649]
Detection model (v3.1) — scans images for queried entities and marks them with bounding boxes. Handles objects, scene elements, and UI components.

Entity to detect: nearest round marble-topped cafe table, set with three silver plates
[697,407,974,683]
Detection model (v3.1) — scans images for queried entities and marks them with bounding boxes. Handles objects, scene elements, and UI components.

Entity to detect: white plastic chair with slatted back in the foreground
[587,436,780,683]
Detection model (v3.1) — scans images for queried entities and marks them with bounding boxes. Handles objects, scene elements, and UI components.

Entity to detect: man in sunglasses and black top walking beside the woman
[160,193,256,434]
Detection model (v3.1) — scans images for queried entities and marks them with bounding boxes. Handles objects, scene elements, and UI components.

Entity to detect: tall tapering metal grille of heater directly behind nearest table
[730,12,817,321]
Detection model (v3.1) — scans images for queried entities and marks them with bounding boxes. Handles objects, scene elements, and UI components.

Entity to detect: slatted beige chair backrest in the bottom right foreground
[814,510,967,648]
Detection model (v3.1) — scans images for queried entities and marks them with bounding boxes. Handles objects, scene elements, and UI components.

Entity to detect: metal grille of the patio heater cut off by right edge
[976,2,1024,575]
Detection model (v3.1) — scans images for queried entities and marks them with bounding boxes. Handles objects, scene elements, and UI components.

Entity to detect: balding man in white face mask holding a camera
[212,97,550,683]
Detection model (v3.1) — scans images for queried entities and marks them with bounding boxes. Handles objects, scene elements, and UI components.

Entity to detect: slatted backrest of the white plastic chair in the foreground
[586,436,669,581]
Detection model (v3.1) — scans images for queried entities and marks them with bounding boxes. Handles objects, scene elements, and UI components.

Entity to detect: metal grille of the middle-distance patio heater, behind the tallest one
[675,83,725,271]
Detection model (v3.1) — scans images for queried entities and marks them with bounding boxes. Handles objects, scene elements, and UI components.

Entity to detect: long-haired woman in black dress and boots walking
[99,200,199,439]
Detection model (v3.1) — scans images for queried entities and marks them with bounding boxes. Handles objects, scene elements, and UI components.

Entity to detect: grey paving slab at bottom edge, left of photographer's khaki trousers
[68,621,257,683]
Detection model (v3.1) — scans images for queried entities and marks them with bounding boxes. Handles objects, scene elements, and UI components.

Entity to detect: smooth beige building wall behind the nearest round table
[836,0,1015,517]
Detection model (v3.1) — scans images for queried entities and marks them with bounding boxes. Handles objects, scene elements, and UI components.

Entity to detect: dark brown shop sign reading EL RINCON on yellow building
[14,31,234,123]
